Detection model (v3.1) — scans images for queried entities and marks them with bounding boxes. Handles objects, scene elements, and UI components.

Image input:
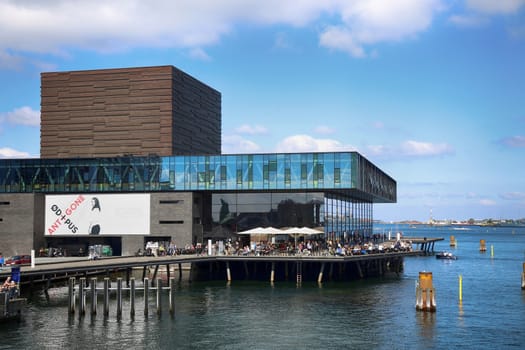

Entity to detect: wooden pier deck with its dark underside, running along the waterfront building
[0,243,442,287]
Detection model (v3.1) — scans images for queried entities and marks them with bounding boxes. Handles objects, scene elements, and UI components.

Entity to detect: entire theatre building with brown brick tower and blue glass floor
[0,66,396,255]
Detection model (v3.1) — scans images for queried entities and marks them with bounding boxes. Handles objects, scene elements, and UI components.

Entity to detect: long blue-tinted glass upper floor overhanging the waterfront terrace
[0,152,396,203]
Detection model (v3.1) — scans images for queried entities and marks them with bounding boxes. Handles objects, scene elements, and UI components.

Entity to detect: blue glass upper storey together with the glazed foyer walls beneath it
[0,152,396,245]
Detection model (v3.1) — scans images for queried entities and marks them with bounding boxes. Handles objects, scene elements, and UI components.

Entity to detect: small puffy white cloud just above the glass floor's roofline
[275,135,355,153]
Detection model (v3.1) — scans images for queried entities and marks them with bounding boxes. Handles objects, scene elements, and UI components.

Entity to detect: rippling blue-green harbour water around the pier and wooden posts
[0,225,525,350]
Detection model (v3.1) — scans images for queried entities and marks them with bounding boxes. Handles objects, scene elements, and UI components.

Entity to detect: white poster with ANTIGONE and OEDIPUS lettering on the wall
[45,193,150,236]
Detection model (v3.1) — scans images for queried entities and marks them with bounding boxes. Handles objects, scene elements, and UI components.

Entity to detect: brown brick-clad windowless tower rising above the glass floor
[40,66,221,158]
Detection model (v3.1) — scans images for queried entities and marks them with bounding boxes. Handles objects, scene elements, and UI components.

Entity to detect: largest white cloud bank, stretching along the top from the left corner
[0,0,442,62]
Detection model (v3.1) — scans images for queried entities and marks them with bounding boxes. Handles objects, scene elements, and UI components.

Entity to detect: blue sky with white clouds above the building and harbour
[0,0,525,221]
